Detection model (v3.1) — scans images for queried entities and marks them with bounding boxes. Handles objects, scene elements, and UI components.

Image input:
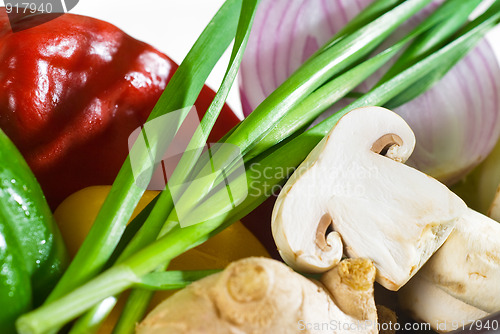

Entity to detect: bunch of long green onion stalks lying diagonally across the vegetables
[17,0,500,334]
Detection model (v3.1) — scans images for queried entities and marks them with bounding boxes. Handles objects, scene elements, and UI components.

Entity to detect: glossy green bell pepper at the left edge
[0,130,68,334]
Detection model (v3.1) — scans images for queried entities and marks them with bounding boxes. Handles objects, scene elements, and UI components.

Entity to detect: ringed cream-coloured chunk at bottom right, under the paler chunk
[398,274,488,333]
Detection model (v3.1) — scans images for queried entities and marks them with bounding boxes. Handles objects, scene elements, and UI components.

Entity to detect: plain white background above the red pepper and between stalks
[2,0,500,117]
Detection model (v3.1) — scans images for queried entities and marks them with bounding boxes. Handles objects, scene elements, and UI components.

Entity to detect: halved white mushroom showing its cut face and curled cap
[272,107,466,290]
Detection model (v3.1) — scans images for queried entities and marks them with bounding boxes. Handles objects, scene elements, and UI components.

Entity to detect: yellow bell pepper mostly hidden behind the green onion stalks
[54,186,269,334]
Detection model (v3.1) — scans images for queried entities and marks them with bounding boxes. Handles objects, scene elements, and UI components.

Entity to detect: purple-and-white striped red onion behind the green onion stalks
[240,0,500,184]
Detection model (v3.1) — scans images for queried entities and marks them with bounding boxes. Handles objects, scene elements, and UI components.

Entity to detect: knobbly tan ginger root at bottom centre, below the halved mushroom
[137,258,377,334]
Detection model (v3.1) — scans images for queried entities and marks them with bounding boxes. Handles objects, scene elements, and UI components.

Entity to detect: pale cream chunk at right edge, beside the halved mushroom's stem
[408,209,500,321]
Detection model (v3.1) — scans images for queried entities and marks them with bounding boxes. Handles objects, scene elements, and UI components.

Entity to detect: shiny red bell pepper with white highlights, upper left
[0,8,238,209]
